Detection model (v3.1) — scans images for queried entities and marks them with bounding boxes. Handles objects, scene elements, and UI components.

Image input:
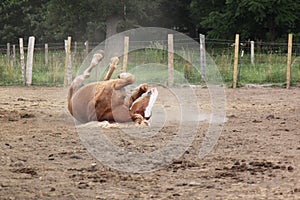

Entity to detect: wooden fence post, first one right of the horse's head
[168,34,174,87]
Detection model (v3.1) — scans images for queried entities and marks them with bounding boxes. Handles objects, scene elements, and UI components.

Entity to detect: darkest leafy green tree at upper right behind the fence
[193,0,300,41]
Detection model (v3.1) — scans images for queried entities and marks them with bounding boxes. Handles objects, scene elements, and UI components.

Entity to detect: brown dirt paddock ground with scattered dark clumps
[0,87,300,200]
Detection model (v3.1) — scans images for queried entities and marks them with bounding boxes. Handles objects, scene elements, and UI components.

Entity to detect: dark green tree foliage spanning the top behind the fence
[0,0,300,44]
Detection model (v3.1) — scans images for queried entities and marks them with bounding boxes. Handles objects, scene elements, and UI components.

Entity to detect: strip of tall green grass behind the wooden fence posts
[0,48,300,86]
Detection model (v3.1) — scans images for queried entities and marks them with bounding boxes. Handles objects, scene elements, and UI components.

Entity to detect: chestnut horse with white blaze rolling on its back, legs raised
[68,52,158,125]
